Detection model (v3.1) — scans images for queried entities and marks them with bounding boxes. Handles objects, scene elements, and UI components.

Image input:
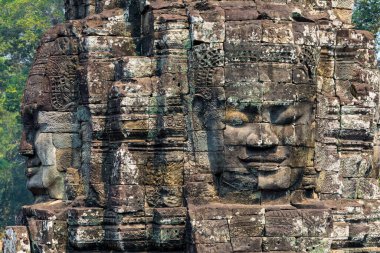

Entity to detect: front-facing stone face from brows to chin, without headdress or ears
[220,91,313,191]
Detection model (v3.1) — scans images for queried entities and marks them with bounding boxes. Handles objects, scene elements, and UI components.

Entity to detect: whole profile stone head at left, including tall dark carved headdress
[20,26,81,201]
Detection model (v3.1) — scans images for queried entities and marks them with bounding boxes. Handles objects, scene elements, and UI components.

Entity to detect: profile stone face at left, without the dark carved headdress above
[21,111,81,201]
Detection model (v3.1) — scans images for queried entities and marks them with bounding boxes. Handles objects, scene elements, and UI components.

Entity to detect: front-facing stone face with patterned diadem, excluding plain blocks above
[193,41,318,203]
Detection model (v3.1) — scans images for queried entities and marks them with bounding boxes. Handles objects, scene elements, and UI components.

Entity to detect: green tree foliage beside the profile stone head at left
[0,0,64,230]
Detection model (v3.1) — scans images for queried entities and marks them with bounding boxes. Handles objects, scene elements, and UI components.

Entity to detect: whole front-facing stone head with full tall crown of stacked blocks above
[190,0,321,204]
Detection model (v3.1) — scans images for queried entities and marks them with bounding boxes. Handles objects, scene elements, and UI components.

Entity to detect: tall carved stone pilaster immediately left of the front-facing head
[142,1,190,250]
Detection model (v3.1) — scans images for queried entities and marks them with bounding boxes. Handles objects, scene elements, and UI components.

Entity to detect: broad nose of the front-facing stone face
[247,124,279,148]
